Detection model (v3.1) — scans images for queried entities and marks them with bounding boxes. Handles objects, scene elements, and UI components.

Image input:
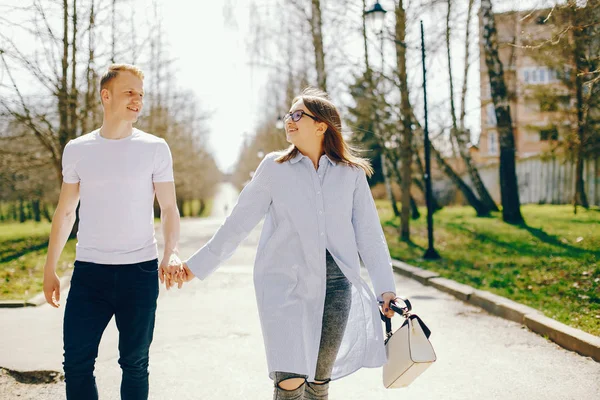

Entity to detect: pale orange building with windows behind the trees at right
[476,10,571,164]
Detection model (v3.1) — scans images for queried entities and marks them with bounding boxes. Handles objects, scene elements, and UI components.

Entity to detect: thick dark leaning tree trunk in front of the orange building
[481,0,524,224]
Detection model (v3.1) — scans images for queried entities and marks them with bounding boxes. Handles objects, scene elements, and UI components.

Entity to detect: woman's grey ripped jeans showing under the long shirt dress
[273,251,352,400]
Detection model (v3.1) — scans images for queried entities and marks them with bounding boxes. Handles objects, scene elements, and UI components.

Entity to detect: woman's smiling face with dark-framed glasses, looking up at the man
[284,99,327,147]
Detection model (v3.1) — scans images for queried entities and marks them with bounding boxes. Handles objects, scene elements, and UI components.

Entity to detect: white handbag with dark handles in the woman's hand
[381,297,437,389]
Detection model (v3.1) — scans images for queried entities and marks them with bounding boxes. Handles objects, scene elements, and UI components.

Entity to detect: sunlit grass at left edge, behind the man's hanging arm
[0,221,75,300]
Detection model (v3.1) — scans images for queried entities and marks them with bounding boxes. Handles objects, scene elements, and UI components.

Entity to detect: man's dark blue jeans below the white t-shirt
[63,260,158,400]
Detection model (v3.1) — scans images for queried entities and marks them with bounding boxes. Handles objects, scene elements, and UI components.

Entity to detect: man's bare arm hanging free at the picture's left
[44,183,79,307]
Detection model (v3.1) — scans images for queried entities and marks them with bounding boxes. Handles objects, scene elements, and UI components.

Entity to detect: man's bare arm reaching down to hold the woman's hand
[154,182,183,289]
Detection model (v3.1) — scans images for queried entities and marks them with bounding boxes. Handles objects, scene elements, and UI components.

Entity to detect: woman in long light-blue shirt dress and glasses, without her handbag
[184,89,395,399]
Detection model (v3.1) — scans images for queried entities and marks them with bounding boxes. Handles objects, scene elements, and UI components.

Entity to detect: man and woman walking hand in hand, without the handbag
[44,64,396,400]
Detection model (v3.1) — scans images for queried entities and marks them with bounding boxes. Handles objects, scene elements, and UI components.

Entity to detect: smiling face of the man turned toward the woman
[102,71,144,123]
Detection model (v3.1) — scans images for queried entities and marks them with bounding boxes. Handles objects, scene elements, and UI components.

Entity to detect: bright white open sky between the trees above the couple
[160,0,265,172]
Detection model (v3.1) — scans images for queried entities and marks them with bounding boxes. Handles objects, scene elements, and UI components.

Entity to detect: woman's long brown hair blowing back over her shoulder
[275,87,373,176]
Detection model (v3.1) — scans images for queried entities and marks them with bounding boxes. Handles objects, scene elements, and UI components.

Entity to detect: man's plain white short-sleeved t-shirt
[62,128,174,264]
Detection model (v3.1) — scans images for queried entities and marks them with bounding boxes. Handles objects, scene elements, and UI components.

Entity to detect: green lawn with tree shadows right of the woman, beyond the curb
[377,201,600,336]
